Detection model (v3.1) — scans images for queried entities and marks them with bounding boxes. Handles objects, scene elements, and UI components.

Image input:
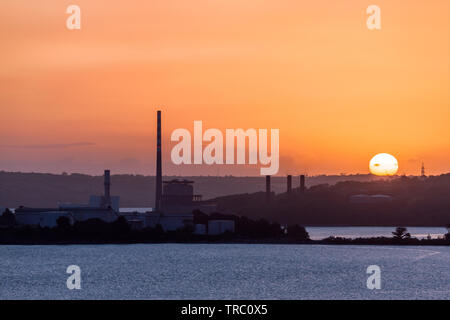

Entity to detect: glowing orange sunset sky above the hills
[0,0,450,175]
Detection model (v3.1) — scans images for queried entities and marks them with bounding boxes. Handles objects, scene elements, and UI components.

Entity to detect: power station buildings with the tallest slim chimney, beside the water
[12,111,227,234]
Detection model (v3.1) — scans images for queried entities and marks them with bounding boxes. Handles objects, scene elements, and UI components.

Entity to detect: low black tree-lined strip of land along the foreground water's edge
[0,212,450,246]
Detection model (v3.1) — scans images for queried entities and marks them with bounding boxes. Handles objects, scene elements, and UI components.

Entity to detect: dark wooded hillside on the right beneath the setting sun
[216,174,450,226]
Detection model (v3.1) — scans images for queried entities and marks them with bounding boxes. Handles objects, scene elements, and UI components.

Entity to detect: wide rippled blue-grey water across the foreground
[0,244,450,299]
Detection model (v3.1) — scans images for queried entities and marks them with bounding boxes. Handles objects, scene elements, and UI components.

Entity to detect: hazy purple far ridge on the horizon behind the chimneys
[0,171,375,208]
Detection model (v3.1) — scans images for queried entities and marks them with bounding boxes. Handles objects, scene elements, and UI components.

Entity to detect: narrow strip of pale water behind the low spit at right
[306,227,447,240]
